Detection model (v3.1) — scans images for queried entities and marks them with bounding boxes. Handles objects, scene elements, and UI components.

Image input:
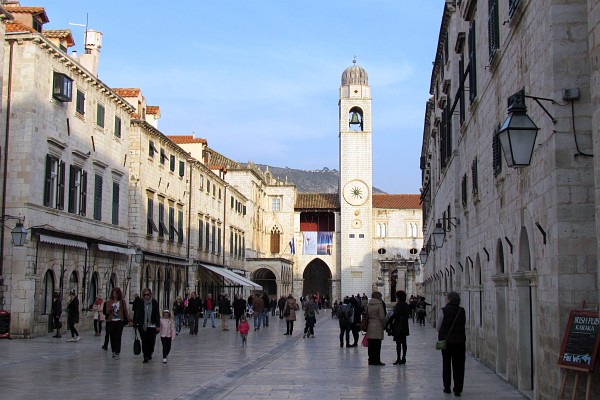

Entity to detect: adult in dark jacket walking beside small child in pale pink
[133,288,160,364]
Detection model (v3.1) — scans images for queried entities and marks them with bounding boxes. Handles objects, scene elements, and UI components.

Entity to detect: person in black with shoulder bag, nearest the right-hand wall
[436,292,467,397]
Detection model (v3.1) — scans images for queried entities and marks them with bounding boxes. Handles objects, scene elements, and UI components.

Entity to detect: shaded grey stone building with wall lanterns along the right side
[421,0,599,399]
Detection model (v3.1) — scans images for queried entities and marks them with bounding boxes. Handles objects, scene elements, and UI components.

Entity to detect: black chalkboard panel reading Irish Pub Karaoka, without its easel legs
[558,310,600,372]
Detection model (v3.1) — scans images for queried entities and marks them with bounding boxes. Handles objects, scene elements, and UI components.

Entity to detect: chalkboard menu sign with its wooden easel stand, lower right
[558,302,600,400]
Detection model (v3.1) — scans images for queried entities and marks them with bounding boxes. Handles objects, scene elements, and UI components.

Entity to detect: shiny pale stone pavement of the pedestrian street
[0,311,525,400]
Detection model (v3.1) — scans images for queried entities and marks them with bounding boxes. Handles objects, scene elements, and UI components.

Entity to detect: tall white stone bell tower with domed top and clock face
[339,59,373,297]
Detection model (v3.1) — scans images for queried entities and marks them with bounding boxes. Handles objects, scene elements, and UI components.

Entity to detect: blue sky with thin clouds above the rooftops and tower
[36,0,444,193]
